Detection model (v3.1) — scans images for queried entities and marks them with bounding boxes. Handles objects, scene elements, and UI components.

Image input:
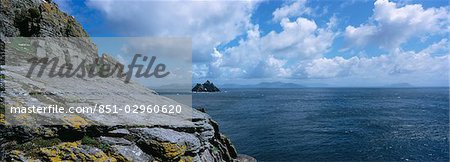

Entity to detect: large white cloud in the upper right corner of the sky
[344,0,449,50]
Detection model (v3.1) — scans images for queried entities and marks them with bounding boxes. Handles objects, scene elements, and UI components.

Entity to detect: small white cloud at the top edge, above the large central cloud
[272,0,312,21]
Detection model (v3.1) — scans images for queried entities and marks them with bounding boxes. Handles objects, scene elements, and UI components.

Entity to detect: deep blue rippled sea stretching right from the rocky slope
[193,88,449,161]
